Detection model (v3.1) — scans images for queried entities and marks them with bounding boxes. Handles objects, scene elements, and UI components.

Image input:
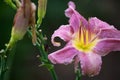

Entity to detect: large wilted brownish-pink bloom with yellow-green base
[7,0,31,49]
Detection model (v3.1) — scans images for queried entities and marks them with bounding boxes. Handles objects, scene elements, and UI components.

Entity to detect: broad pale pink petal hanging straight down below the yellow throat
[79,53,102,77]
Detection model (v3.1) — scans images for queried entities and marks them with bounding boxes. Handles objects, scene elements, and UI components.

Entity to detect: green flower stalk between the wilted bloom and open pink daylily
[28,27,58,80]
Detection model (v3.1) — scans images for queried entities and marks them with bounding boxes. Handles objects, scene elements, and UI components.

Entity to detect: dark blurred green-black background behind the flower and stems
[0,0,120,80]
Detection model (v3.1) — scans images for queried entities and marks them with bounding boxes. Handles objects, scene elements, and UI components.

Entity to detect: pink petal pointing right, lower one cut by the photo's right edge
[93,38,120,56]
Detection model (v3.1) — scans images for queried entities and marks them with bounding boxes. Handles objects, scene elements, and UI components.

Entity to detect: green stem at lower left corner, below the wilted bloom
[0,46,15,80]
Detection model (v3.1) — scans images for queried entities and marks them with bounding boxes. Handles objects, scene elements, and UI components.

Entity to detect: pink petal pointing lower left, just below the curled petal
[48,46,77,64]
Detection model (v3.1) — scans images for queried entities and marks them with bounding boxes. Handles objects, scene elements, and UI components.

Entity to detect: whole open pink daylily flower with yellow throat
[48,1,120,76]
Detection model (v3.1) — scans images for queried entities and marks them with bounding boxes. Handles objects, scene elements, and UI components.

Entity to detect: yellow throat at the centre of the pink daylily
[73,26,98,52]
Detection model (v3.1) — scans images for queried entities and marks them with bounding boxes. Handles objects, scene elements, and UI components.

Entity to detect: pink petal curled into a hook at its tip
[51,25,72,46]
